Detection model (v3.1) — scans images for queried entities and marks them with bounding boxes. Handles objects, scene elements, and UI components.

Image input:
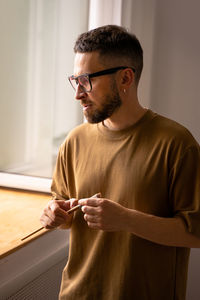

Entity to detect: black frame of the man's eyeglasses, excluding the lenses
[68,66,135,93]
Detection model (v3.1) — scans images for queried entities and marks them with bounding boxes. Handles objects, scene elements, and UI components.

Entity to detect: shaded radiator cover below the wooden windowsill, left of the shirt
[0,229,69,300]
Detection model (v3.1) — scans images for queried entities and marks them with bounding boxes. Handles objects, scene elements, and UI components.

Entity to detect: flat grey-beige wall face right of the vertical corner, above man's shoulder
[150,0,200,142]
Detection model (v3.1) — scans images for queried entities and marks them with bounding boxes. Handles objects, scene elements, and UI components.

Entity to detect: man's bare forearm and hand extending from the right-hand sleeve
[78,198,200,248]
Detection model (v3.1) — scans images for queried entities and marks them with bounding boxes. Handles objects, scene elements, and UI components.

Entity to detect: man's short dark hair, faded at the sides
[74,25,143,84]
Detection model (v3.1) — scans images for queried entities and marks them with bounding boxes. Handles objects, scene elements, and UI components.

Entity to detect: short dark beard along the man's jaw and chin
[84,82,122,124]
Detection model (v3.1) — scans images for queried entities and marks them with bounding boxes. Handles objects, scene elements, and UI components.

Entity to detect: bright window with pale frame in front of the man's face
[0,0,89,180]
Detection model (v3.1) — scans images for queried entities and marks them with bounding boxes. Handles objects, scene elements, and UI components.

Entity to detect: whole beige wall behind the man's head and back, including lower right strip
[122,0,200,300]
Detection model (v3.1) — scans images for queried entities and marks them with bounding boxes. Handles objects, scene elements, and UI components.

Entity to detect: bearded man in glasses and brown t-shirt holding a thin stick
[41,25,200,300]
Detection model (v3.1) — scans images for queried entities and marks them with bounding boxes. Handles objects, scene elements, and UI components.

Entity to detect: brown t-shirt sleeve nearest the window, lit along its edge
[51,145,69,200]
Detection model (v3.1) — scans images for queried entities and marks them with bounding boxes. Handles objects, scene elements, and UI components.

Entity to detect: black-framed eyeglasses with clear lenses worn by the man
[68,66,135,93]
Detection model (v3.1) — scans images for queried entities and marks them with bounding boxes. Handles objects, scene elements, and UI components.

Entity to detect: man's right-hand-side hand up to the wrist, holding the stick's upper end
[78,198,127,231]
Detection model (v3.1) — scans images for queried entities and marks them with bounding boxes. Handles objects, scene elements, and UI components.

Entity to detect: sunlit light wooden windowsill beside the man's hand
[0,187,51,258]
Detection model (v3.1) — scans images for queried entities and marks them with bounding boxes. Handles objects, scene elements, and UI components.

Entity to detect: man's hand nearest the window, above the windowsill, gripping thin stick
[40,199,78,229]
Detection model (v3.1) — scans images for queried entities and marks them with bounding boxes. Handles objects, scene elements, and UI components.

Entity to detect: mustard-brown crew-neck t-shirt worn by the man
[52,110,200,300]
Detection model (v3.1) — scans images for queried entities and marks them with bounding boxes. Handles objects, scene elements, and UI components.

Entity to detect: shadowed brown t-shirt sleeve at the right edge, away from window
[170,144,200,237]
